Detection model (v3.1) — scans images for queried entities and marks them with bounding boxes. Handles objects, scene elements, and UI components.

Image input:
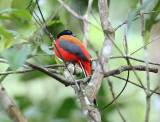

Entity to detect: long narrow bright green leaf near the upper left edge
[0,9,31,19]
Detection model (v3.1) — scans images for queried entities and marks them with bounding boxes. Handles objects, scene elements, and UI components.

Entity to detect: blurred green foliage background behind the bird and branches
[0,0,160,122]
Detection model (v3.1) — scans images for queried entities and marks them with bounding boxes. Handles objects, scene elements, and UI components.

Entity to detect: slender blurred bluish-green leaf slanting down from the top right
[127,0,154,28]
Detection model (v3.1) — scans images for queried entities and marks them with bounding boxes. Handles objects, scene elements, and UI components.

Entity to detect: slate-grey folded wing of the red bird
[59,39,89,62]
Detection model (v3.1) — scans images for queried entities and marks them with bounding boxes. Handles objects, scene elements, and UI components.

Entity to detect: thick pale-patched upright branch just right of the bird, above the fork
[86,0,115,105]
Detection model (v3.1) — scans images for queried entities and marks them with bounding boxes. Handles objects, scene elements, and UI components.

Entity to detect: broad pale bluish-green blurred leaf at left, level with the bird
[2,46,29,70]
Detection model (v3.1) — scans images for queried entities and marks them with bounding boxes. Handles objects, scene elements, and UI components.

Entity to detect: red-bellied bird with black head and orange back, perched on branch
[54,30,91,77]
